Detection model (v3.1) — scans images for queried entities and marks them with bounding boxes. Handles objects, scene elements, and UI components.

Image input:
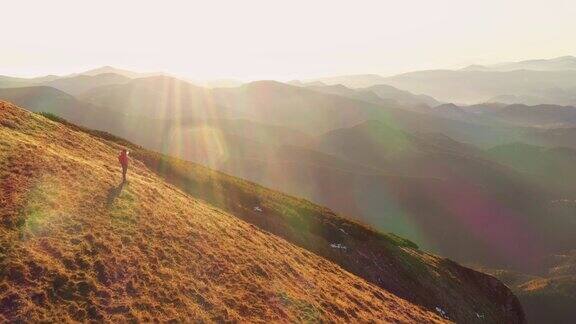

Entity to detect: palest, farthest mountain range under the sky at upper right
[293,56,576,106]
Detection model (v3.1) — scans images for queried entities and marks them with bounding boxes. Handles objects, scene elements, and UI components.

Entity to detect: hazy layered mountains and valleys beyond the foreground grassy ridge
[0,60,576,320]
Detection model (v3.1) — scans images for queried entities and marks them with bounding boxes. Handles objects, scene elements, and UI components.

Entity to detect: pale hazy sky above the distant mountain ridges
[0,0,576,80]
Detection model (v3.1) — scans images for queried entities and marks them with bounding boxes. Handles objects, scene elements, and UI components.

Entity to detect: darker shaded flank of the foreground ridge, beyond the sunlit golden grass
[2,100,523,322]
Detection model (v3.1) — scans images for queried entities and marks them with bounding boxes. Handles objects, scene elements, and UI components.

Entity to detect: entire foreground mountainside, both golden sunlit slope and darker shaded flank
[0,100,523,323]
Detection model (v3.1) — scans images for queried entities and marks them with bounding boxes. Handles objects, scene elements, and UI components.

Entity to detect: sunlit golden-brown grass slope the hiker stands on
[0,102,446,323]
